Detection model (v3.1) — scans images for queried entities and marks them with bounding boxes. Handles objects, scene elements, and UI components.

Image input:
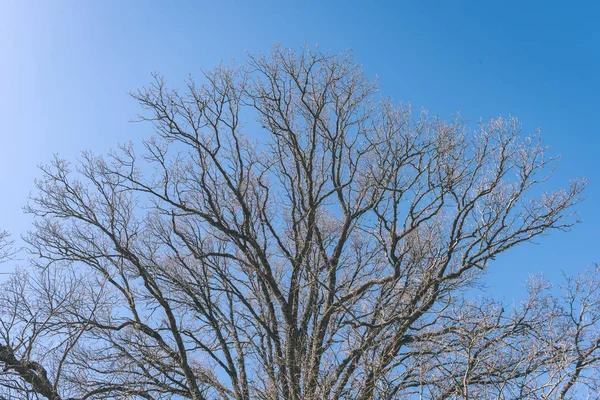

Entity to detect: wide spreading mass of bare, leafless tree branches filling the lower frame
[0,47,600,400]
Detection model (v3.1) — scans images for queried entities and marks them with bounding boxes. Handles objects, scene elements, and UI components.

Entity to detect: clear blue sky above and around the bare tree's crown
[0,0,600,298]
